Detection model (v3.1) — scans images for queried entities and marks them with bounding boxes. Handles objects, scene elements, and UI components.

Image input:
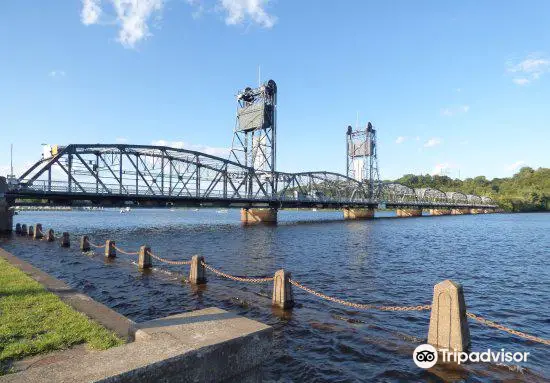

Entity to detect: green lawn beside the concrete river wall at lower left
[0,258,124,375]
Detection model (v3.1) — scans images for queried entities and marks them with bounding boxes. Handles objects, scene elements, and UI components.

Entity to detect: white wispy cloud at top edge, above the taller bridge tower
[219,0,277,28]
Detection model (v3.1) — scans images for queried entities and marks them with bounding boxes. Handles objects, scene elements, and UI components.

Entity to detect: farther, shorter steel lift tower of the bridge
[346,122,380,198]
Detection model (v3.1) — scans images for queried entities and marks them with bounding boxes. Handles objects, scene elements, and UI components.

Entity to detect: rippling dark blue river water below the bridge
[0,209,550,382]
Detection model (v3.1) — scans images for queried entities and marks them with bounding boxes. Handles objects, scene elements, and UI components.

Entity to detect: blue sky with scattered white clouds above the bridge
[0,0,550,179]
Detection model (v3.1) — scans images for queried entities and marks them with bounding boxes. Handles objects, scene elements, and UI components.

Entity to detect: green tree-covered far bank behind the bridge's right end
[395,166,550,212]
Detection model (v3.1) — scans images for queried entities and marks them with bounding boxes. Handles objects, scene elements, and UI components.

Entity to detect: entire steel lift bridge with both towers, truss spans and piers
[4,80,497,223]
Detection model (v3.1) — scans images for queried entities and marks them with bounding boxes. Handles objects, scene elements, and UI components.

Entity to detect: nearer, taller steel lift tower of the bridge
[229,80,277,194]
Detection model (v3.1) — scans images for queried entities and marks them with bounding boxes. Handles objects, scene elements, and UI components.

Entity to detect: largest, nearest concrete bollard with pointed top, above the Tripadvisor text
[428,279,470,351]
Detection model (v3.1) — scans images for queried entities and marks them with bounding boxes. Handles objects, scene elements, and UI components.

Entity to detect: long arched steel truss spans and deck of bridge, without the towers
[5,144,497,209]
